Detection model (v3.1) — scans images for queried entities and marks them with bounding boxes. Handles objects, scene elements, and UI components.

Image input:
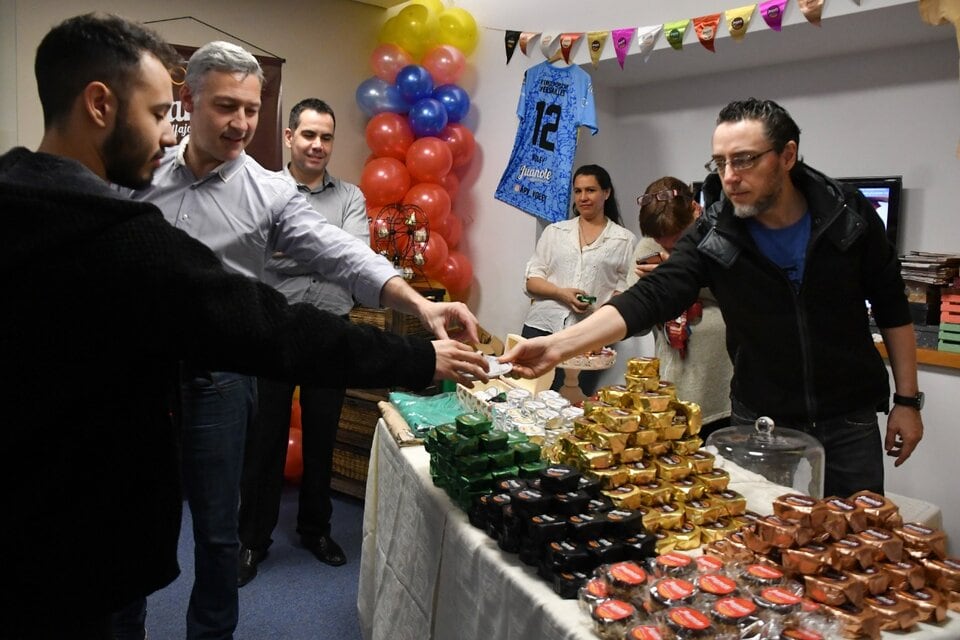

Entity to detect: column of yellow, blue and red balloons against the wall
[356,0,477,296]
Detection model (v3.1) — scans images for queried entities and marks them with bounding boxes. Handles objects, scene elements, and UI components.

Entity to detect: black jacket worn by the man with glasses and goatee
[610,163,911,424]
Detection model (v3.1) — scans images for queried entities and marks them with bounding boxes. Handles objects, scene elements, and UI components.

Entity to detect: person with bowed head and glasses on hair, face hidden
[627,176,733,440]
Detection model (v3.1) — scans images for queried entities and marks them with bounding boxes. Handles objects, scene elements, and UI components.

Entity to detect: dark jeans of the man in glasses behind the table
[730,398,883,498]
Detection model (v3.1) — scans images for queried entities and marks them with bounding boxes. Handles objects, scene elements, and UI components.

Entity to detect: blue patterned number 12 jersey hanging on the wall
[494,62,598,222]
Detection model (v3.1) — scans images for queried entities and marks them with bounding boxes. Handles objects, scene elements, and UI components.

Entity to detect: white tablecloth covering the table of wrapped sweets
[357,421,960,640]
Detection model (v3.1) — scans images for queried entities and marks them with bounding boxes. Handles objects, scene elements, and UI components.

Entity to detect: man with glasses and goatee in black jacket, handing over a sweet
[501,99,923,496]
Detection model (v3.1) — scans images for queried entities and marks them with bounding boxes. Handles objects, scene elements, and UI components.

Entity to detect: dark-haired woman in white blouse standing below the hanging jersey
[521,164,637,396]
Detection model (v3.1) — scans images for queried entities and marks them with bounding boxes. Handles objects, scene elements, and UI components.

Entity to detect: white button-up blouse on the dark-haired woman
[523,218,637,333]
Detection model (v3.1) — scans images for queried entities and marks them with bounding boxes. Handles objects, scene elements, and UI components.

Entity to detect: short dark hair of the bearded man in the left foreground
[34,13,182,128]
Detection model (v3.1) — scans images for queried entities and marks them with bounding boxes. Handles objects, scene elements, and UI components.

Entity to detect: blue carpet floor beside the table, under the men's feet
[147,487,363,640]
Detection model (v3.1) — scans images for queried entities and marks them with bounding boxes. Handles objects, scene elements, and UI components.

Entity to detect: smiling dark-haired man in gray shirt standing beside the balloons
[239,98,370,587]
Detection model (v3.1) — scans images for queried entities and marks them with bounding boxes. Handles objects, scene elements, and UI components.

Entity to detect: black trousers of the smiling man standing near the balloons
[240,378,346,550]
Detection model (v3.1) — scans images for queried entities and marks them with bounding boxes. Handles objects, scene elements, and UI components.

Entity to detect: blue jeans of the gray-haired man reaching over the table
[181,372,257,640]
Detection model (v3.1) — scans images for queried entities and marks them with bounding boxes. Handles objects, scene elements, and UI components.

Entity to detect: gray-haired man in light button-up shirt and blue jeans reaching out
[127,42,480,638]
